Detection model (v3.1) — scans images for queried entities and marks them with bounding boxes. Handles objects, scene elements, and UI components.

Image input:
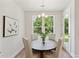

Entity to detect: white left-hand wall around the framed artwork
[0,0,24,58]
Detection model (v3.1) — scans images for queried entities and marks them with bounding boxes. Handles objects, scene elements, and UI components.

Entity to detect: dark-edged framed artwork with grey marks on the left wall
[3,16,18,37]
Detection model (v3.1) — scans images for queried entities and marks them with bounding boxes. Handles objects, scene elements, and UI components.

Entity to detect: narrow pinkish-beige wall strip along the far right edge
[74,0,79,57]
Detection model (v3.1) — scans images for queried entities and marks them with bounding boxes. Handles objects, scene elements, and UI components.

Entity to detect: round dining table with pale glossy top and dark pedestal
[32,39,57,58]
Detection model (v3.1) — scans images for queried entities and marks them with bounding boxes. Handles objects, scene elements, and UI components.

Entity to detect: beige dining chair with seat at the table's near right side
[44,39,62,58]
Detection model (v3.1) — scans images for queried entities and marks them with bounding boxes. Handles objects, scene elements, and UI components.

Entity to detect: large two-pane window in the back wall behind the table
[33,16,53,35]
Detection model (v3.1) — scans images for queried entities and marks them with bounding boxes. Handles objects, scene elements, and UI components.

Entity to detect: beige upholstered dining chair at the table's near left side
[23,38,40,58]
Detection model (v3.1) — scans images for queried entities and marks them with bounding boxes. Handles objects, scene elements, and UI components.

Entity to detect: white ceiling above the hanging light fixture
[15,0,70,11]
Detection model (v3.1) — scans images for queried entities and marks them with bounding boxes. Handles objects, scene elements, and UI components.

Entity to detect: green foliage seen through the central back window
[34,16,53,37]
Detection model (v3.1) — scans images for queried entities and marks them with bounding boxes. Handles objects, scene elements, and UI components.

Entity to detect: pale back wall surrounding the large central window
[25,11,62,39]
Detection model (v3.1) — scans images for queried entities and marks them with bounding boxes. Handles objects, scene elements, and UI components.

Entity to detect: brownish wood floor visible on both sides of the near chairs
[15,49,71,58]
